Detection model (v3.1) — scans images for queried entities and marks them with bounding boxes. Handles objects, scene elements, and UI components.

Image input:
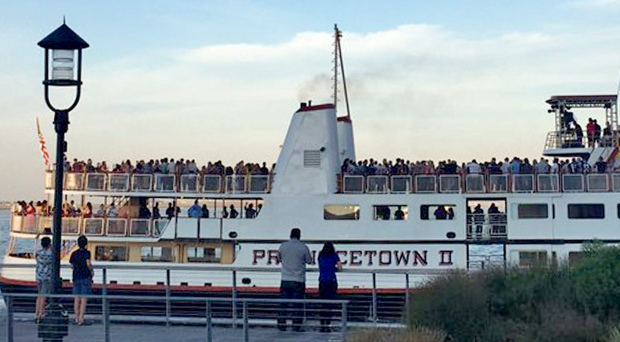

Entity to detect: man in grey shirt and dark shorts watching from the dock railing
[278,228,312,331]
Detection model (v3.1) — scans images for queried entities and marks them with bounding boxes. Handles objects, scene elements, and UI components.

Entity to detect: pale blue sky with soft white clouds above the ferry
[0,0,620,200]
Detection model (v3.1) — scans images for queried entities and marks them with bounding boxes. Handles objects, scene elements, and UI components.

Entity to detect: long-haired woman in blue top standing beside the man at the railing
[319,242,342,332]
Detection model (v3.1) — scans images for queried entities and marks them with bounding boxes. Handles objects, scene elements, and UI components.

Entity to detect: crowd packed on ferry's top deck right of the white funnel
[341,157,620,176]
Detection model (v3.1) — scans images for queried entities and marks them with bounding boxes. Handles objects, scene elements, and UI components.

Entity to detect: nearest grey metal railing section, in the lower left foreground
[3,291,348,342]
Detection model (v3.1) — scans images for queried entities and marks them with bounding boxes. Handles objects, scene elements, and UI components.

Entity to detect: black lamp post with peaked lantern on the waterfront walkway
[38,20,88,341]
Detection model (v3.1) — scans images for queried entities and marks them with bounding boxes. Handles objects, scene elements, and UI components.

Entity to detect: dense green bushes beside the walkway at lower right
[402,243,620,342]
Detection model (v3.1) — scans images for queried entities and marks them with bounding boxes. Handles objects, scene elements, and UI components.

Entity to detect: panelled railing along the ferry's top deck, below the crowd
[46,170,620,198]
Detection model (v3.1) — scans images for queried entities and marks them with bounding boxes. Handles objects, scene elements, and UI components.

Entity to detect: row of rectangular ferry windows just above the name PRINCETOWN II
[323,203,620,221]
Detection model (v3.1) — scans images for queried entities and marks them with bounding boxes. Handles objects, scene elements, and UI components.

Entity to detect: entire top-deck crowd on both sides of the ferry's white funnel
[50,152,620,182]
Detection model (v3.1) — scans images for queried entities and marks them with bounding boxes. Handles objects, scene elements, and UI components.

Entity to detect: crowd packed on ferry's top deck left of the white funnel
[63,158,275,176]
